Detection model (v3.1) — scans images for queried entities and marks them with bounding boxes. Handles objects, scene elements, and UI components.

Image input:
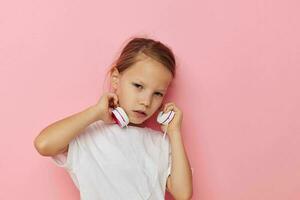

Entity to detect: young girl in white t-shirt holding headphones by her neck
[34,38,193,200]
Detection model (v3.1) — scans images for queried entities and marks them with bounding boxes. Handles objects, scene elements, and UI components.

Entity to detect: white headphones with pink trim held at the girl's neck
[112,107,175,138]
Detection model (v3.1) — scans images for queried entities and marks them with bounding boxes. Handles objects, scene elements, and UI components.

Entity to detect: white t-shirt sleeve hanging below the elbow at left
[51,137,79,171]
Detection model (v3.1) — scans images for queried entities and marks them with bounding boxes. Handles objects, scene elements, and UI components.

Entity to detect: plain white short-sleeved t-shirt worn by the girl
[51,120,171,200]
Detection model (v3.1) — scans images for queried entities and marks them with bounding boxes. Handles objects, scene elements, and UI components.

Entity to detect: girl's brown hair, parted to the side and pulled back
[103,37,176,91]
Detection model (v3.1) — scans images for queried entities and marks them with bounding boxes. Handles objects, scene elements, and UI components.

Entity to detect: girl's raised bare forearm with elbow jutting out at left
[34,106,101,156]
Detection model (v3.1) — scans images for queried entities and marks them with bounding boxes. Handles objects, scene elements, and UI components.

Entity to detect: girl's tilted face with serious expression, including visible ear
[111,54,173,124]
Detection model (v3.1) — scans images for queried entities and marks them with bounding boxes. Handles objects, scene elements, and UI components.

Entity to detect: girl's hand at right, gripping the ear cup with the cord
[161,102,183,137]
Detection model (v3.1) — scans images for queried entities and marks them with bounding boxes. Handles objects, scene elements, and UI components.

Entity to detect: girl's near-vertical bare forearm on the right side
[170,132,193,199]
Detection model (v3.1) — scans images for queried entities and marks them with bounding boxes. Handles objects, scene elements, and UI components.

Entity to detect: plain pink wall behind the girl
[0,0,300,200]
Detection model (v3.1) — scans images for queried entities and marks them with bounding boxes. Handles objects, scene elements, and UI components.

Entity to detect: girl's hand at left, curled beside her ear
[95,92,119,123]
